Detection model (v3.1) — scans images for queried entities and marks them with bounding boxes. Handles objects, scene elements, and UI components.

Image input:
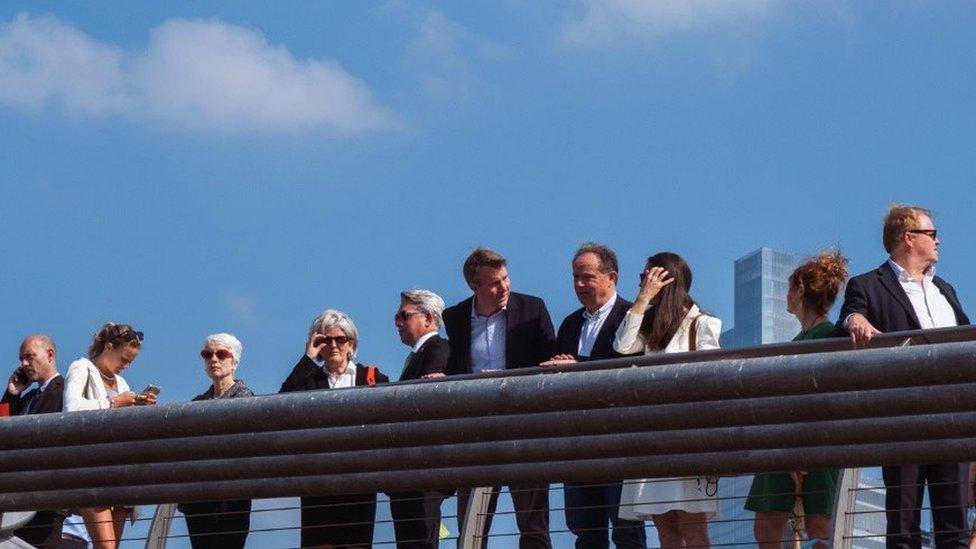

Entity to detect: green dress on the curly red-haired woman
[746,322,838,516]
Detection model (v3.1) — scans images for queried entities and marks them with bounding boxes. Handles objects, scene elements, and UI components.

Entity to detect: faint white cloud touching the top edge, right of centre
[559,0,772,48]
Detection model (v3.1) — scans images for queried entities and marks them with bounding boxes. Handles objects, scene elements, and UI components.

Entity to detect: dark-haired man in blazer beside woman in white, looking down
[543,242,647,549]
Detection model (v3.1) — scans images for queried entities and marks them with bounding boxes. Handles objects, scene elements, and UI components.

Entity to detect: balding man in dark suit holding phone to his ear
[0,335,64,547]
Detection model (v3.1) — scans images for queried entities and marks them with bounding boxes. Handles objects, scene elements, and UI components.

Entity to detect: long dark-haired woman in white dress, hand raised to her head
[613,252,722,549]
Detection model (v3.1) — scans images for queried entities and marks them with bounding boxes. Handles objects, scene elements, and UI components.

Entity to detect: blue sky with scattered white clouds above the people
[0,0,976,544]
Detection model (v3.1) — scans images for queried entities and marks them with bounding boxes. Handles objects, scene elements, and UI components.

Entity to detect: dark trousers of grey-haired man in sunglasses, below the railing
[390,492,448,549]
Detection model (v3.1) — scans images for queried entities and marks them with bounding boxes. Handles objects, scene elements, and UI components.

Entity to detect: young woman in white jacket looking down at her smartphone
[64,323,158,549]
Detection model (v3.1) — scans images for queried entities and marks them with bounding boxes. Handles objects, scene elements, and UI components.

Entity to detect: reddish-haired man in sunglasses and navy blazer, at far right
[838,206,969,549]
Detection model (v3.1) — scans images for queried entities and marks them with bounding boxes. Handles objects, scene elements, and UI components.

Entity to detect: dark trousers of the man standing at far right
[882,463,969,549]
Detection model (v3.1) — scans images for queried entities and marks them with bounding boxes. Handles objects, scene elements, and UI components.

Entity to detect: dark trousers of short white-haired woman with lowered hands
[180,500,251,549]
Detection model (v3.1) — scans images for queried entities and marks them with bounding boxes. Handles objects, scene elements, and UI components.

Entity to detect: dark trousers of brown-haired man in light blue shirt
[458,484,552,549]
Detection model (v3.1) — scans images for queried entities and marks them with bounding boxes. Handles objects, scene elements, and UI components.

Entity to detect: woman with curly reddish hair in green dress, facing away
[745,251,847,549]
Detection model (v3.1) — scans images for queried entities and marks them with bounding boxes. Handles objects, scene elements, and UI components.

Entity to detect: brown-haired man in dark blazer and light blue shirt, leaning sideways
[444,248,556,549]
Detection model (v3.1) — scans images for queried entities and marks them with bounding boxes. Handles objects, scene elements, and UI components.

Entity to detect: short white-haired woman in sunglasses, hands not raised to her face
[179,333,254,549]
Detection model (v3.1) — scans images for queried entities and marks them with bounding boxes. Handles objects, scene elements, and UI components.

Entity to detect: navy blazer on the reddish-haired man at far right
[837,261,969,335]
